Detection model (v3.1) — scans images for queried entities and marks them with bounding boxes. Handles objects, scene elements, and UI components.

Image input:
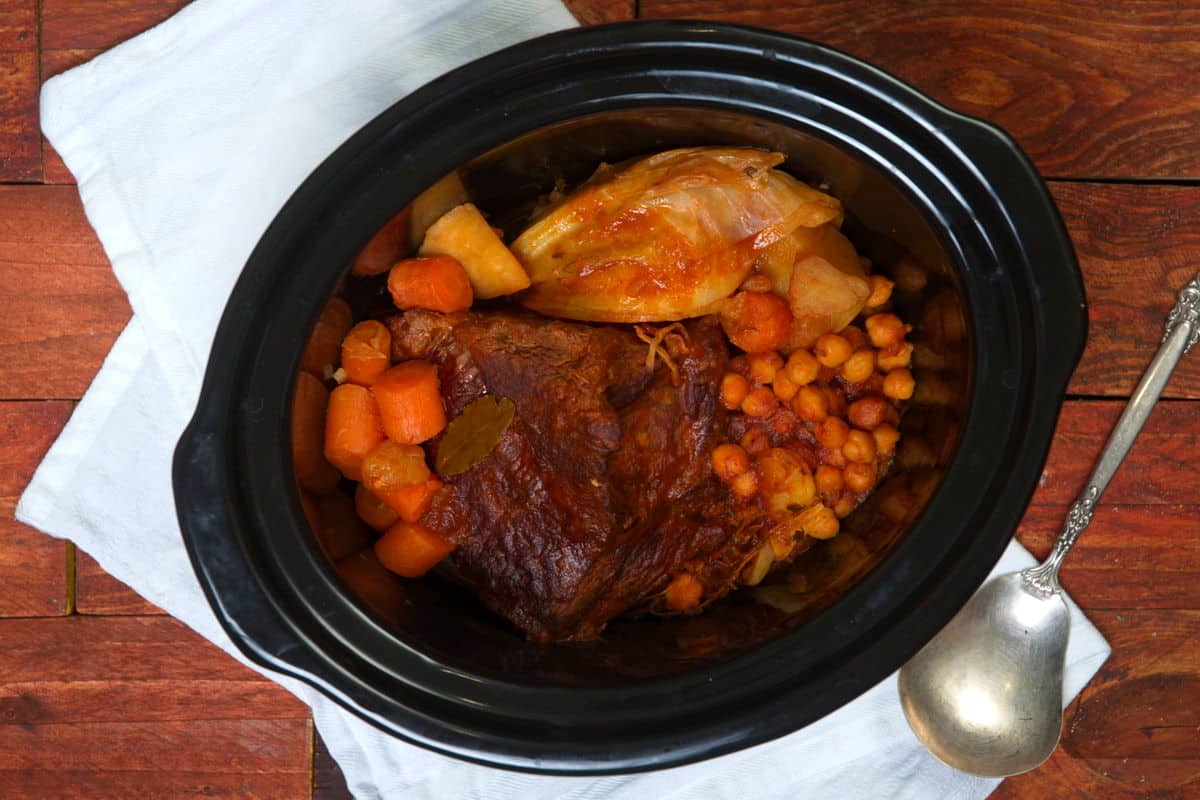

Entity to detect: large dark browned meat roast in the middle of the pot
[389,311,769,640]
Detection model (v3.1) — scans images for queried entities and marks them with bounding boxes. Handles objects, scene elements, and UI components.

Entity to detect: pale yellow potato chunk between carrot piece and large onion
[420,203,529,300]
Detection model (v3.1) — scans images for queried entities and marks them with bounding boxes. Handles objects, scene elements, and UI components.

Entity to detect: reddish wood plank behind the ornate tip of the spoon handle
[1051,184,1200,397]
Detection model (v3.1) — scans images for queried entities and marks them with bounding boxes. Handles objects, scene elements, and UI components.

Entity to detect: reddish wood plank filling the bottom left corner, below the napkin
[0,616,312,798]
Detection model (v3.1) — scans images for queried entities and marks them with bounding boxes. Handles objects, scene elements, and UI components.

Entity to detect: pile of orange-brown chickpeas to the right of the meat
[712,276,916,556]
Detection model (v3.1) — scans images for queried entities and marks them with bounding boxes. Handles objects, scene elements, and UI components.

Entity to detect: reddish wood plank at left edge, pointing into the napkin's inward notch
[0,186,130,398]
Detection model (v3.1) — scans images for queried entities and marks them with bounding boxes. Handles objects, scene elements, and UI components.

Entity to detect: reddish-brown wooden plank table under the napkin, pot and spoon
[0,0,1200,800]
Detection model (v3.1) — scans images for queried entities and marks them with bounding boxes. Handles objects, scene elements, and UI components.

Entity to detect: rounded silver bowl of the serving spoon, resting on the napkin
[900,572,1070,777]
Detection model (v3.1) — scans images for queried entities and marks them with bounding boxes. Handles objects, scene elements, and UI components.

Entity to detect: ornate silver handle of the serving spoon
[1021,273,1200,595]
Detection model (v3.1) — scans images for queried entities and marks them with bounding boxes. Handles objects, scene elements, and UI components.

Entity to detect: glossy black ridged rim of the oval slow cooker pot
[173,22,1086,774]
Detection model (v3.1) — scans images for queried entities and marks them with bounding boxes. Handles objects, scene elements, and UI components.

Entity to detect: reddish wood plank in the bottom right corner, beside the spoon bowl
[992,609,1200,800]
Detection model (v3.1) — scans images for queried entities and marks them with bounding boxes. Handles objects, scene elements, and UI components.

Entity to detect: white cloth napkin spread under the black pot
[17,0,1109,800]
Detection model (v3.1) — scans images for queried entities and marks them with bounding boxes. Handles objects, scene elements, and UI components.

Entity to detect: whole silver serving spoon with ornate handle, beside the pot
[900,268,1200,777]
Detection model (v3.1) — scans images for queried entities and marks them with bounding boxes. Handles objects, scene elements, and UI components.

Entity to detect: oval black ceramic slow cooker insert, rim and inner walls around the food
[174,23,1086,774]
